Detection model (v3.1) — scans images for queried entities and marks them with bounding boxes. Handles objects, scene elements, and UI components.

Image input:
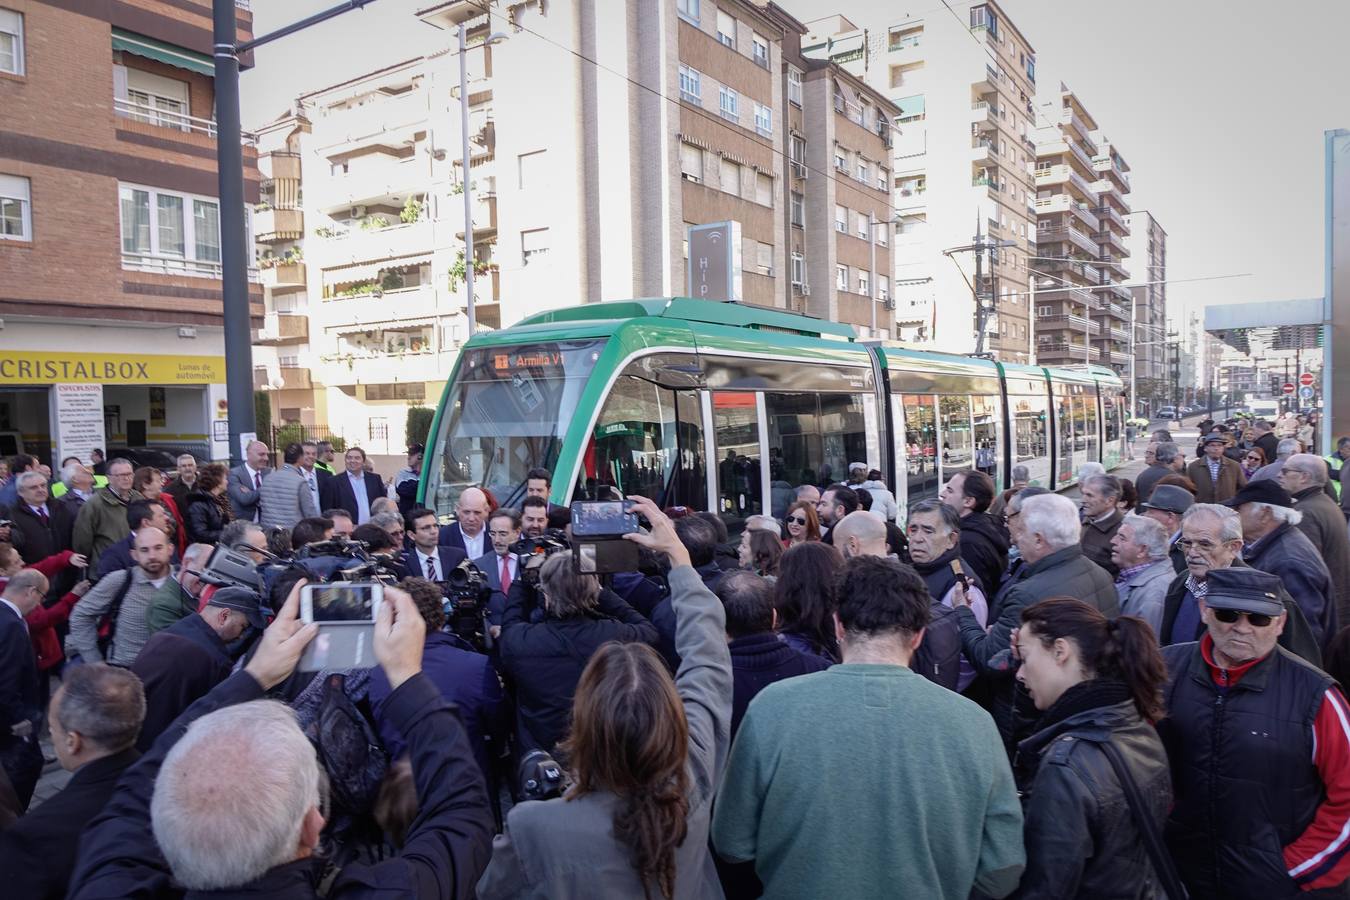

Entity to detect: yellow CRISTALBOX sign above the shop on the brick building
[0,349,225,385]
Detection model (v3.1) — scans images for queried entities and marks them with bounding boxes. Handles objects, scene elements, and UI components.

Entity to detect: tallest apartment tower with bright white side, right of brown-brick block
[806,3,1035,362]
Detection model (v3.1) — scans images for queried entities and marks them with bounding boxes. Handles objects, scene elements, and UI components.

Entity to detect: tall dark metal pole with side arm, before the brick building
[211,0,374,466]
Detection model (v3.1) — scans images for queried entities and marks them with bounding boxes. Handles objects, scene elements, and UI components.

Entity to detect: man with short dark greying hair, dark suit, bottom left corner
[0,665,146,900]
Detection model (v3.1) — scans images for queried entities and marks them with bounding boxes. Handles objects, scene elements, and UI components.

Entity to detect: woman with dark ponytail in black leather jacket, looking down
[1014,596,1172,900]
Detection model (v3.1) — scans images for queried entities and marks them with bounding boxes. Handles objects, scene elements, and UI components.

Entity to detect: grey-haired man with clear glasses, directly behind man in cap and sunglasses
[1158,503,1322,665]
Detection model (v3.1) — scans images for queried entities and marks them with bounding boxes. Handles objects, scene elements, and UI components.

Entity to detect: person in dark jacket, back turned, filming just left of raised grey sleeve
[498,542,658,756]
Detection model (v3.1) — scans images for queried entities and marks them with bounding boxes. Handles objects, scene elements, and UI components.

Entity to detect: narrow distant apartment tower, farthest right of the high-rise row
[1126,210,1170,412]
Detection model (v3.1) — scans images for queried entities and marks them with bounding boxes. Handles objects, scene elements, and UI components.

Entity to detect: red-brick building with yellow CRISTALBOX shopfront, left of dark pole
[0,0,262,467]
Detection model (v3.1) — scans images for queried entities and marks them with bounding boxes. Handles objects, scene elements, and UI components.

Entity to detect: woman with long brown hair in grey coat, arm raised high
[478,497,732,900]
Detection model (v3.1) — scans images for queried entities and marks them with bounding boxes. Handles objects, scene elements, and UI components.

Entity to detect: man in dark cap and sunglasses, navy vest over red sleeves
[1157,569,1350,900]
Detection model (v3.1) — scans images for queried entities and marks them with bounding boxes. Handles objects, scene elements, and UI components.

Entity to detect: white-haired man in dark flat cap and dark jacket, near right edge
[1224,479,1337,650]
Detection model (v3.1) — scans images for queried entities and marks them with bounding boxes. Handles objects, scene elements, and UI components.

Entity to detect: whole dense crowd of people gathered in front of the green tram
[0,421,1350,900]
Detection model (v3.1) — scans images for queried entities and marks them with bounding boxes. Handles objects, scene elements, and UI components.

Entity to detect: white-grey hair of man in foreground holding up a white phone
[150,700,319,891]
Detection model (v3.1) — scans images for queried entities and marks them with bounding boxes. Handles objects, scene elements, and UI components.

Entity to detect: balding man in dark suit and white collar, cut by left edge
[0,569,47,812]
